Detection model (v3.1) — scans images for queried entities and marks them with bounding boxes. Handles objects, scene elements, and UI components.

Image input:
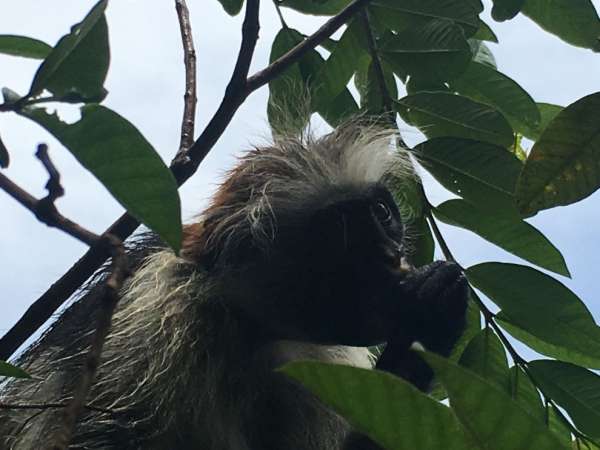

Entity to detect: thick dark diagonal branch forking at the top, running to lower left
[0,0,369,360]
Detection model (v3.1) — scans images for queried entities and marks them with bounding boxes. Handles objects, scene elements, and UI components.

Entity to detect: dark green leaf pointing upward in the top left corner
[27,0,110,102]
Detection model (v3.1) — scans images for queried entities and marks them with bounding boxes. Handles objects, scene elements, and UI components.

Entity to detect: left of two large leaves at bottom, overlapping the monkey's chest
[281,362,474,450]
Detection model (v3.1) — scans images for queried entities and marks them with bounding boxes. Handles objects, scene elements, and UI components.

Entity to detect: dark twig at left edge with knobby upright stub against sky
[0,144,103,246]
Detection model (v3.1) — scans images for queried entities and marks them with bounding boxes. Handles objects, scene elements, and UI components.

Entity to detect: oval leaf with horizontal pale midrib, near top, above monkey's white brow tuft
[381,19,471,82]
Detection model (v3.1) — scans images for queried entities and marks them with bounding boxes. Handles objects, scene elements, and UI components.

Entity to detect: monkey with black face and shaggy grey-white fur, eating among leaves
[0,122,467,450]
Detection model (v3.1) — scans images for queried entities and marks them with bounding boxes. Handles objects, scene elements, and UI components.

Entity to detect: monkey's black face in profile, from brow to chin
[225,184,412,345]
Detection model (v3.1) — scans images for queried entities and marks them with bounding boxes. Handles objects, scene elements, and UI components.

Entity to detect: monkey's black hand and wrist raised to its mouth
[376,261,468,390]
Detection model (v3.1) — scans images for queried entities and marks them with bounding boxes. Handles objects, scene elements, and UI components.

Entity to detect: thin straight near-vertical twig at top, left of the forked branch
[175,0,197,154]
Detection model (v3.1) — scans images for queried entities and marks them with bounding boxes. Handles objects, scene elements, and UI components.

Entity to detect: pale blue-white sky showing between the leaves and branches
[0,0,600,358]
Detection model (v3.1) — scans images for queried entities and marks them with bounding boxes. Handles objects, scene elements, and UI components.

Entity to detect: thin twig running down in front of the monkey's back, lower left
[50,236,129,450]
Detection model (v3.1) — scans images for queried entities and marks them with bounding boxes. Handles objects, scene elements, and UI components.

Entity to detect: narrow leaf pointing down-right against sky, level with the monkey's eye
[433,199,570,277]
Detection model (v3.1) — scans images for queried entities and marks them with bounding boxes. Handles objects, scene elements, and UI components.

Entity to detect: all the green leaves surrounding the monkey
[0,0,600,450]
